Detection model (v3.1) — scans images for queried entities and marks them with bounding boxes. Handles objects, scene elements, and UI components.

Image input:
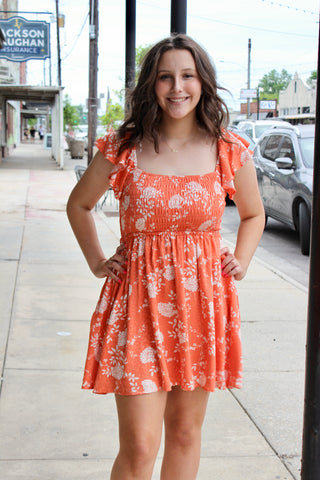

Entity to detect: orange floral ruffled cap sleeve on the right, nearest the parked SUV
[218,132,252,199]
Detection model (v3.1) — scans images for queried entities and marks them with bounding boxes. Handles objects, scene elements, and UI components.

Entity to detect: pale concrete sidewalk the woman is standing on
[0,145,307,480]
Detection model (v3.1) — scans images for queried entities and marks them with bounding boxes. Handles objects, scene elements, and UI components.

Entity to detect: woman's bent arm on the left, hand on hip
[67,152,125,281]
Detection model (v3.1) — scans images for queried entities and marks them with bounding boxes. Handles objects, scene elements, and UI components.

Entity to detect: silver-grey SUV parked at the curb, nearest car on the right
[253,125,315,255]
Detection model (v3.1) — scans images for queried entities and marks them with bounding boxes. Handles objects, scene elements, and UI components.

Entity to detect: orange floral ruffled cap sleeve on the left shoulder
[96,130,135,199]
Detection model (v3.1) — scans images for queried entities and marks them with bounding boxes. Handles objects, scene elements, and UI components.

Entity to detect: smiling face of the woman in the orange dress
[155,50,201,120]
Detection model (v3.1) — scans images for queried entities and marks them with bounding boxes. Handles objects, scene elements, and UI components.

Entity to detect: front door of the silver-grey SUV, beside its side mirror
[272,135,296,222]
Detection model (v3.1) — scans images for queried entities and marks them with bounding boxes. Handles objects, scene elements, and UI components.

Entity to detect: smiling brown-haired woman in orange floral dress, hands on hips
[67,35,264,480]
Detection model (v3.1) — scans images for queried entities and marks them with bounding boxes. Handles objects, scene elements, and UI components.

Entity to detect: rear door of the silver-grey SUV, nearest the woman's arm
[258,135,282,214]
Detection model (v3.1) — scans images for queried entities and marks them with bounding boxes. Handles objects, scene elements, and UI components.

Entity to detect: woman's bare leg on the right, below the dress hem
[161,387,209,480]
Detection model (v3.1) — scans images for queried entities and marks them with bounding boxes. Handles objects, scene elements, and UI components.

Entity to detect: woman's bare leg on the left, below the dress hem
[110,391,167,480]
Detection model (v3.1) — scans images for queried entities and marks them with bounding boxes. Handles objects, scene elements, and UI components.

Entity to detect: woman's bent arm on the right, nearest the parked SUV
[220,160,265,280]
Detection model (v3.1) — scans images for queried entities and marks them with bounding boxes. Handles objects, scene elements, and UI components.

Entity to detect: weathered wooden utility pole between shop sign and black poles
[88,0,99,165]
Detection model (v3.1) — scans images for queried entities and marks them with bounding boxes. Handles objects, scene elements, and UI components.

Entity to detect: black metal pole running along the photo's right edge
[301,14,320,480]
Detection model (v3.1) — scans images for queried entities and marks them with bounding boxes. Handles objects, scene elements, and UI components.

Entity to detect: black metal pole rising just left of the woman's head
[125,0,136,110]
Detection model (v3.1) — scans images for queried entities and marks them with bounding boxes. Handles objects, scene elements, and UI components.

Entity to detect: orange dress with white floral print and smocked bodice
[82,132,251,395]
